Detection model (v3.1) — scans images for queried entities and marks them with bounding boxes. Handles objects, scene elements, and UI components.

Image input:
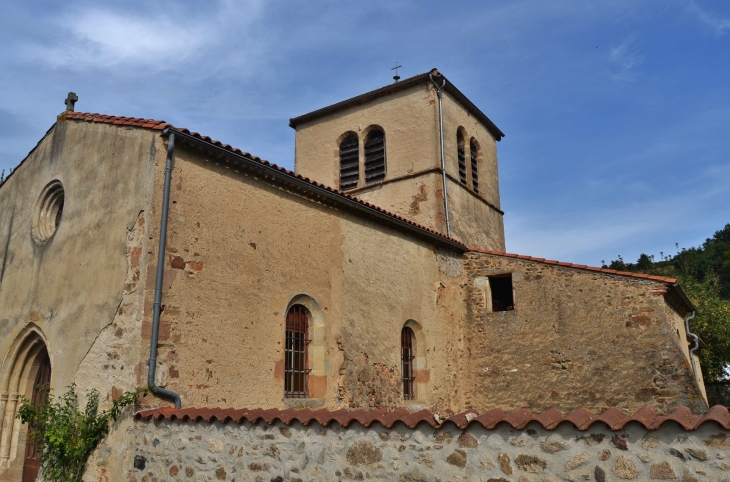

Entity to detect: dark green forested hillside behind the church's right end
[602,224,730,381]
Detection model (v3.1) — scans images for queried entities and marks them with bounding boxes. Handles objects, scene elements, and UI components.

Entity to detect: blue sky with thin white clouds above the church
[0,0,730,265]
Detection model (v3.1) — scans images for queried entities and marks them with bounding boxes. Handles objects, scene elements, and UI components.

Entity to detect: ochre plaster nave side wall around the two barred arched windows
[139,145,466,409]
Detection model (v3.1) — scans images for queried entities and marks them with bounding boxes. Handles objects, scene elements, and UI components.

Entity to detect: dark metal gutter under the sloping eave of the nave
[162,127,468,252]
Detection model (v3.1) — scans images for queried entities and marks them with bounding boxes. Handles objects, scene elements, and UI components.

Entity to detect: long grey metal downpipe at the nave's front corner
[147,132,182,408]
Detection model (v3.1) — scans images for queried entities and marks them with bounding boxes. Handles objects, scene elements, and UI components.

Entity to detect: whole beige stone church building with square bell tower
[0,69,708,481]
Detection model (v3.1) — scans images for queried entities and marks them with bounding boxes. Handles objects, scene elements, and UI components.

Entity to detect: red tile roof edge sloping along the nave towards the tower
[61,112,467,250]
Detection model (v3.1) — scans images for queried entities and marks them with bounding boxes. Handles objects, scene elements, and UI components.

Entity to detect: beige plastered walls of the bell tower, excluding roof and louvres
[295,84,504,250]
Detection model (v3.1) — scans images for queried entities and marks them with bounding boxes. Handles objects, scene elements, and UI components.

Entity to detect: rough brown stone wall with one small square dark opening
[461,253,707,413]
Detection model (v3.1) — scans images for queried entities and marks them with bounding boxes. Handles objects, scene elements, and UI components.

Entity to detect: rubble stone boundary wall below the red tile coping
[131,420,730,482]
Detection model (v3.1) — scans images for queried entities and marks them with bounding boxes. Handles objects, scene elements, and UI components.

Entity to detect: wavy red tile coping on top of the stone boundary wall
[135,405,730,430]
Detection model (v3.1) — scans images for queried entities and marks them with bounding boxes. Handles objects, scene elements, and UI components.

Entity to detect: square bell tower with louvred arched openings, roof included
[289,69,505,251]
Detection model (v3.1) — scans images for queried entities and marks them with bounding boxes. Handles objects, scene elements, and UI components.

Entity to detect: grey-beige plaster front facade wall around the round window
[0,121,158,480]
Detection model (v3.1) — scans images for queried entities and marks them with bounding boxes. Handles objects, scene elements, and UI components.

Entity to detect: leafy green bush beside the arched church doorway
[18,385,144,482]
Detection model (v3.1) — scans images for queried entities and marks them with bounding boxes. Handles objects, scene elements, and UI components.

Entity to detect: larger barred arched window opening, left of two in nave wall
[284,305,310,398]
